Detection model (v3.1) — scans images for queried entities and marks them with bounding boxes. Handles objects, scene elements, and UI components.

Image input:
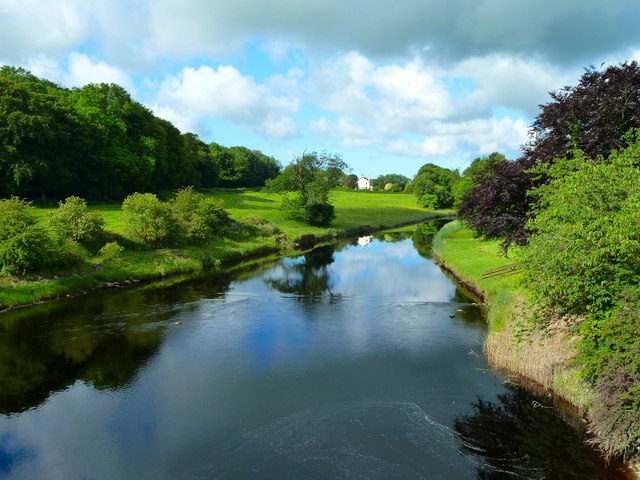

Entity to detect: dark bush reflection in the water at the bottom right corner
[455,389,598,479]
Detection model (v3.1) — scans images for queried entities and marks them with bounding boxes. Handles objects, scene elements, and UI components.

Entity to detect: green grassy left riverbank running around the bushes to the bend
[0,191,451,310]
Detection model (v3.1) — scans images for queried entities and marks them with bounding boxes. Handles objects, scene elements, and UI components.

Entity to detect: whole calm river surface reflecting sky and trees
[0,227,632,479]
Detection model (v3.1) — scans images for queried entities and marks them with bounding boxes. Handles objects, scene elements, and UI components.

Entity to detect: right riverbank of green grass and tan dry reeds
[433,221,640,478]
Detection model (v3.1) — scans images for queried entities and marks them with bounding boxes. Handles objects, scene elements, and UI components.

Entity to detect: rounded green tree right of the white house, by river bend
[413,163,459,210]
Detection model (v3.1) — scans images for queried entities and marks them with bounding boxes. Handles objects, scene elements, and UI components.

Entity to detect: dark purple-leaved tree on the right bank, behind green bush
[460,61,640,246]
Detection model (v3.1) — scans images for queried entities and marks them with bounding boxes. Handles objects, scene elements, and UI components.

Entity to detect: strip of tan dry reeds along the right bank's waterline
[434,225,640,480]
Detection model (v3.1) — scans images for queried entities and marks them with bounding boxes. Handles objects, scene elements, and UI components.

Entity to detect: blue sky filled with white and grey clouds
[0,0,640,177]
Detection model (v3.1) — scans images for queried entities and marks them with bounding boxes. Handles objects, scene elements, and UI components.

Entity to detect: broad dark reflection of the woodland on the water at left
[0,275,231,414]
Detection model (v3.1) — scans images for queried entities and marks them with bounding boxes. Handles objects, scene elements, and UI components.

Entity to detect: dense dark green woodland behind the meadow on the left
[0,66,281,200]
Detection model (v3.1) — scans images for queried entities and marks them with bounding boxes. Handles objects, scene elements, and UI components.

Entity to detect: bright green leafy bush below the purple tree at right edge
[525,138,640,314]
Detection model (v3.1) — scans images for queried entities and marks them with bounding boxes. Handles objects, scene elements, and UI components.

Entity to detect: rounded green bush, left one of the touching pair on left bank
[122,193,175,245]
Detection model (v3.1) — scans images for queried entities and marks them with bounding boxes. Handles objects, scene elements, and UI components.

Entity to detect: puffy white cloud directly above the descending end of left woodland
[154,65,299,139]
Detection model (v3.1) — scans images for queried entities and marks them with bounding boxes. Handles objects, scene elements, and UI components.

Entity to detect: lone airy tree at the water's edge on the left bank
[282,152,348,226]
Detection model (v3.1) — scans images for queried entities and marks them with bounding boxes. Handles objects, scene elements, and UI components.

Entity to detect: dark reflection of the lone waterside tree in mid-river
[265,245,334,301]
